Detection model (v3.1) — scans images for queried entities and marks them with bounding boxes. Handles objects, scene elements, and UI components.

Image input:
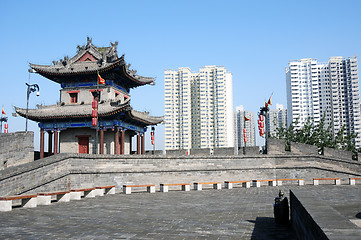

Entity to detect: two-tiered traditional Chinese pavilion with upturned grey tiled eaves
[15,38,163,158]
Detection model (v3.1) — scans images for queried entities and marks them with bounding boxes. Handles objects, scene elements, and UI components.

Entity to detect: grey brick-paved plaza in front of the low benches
[0,185,361,239]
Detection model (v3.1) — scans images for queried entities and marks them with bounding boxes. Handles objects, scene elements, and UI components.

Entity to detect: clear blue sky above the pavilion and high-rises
[0,0,361,149]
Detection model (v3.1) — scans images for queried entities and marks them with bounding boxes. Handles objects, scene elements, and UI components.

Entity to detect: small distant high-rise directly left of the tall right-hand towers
[267,104,287,136]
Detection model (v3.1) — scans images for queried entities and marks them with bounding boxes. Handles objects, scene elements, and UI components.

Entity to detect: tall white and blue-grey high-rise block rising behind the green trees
[286,57,361,147]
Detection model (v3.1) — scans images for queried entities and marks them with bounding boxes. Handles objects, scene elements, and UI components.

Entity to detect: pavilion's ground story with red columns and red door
[40,127,145,158]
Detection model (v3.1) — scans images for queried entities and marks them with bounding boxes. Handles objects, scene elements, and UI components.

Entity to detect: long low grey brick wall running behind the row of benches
[0,153,361,196]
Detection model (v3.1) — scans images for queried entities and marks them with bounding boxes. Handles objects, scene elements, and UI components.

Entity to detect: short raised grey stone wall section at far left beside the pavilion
[0,132,34,170]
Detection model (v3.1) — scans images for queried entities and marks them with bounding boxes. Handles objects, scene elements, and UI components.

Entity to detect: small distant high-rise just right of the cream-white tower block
[234,105,256,147]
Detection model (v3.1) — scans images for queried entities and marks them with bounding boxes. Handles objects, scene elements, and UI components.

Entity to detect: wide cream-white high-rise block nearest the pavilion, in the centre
[164,66,234,150]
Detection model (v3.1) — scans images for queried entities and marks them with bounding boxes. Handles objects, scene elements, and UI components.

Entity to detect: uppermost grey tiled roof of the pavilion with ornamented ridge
[30,38,154,88]
